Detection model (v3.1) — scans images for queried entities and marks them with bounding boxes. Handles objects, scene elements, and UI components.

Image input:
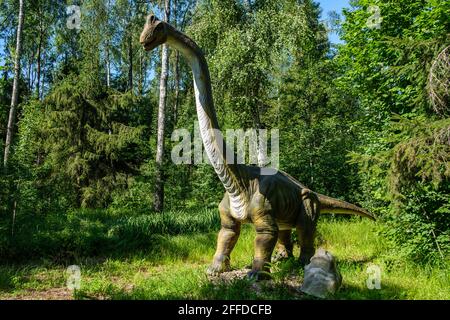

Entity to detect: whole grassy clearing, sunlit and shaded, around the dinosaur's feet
[0,210,450,299]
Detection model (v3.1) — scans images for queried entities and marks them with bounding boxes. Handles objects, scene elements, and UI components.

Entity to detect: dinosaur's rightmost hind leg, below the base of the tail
[297,189,320,266]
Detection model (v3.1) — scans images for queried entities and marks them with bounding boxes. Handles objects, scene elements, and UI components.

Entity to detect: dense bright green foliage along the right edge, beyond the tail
[336,0,450,262]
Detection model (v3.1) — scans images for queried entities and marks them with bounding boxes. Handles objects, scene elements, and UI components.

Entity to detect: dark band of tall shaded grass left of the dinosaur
[0,210,220,262]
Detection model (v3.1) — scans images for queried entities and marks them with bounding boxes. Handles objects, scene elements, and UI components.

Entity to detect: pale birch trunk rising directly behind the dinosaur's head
[154,0,170,212]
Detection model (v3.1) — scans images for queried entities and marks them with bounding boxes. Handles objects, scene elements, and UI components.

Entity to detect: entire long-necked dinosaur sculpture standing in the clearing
[140,15,374,277]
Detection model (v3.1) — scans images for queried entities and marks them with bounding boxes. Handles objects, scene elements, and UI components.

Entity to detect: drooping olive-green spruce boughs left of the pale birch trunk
[12,76,146,210]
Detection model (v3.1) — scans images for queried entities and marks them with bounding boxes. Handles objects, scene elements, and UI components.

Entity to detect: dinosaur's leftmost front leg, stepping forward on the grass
[207,209,241,275]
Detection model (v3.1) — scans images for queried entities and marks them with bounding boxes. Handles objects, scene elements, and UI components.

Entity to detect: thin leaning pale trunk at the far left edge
[3,0,24,168]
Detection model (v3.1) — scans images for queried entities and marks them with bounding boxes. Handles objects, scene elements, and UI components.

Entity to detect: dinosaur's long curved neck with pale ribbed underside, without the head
[167,25,248,219]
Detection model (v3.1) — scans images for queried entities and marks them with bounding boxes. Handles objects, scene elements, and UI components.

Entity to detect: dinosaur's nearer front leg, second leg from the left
[248,213,278,279]
